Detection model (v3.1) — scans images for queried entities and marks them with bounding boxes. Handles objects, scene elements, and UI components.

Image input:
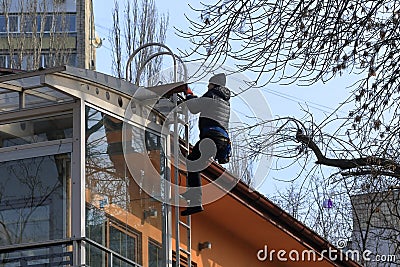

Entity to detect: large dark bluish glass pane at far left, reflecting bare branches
[0,154,70,266]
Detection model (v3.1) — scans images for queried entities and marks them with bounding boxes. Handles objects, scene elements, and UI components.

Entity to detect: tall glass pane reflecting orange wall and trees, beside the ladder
[86,108,165,266]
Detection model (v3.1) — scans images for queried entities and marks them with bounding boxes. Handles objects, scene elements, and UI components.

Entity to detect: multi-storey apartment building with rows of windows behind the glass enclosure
[0,0,99,70]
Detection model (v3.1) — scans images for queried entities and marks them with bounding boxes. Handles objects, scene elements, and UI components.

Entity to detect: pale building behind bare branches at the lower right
[349,192,400,267]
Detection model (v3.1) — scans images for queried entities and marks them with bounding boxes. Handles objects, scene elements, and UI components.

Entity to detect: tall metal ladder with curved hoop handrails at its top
[125,43,192,267]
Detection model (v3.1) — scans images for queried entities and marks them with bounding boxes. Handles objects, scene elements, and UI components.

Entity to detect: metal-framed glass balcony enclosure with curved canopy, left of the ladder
[0,67,172,266]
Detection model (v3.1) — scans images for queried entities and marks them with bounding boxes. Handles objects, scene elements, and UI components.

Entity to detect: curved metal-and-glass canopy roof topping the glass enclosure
[0,66,186,117]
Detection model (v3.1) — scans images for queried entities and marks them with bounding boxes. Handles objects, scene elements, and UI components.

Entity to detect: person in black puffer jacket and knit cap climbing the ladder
[181,73,231,216]
